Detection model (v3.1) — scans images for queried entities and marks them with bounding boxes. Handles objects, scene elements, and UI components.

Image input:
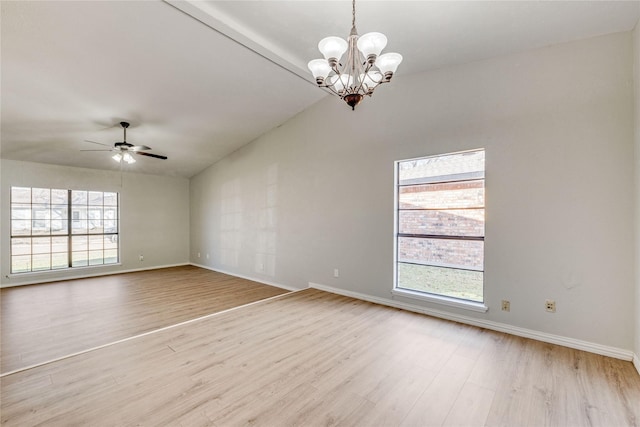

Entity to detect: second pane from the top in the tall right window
[398,180,484,209]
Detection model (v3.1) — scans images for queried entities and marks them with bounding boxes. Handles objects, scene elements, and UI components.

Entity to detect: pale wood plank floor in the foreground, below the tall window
[0,289,640,427]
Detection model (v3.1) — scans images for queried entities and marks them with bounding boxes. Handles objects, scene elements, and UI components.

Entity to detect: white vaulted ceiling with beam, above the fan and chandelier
[0,0,640,177]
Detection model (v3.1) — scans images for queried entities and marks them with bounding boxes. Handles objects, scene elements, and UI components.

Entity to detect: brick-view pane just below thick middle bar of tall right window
[398,237,484,270]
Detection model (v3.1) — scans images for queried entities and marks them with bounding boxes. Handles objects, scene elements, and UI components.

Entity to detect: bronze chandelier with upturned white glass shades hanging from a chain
[308,0,402,110]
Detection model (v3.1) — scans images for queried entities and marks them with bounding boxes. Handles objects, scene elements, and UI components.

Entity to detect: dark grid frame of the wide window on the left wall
[9,185,121,276]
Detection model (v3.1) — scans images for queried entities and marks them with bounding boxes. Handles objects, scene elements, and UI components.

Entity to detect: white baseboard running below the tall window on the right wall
[309,282,640,362]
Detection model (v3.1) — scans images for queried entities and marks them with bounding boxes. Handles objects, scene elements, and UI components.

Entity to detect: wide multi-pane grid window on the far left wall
[11,187,118,273]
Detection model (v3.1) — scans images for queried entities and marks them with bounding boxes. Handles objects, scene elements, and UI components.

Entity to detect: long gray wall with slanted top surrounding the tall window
[190,33,637,351]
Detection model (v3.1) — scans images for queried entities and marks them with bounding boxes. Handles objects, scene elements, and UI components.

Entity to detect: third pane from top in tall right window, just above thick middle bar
[398,209,484,236]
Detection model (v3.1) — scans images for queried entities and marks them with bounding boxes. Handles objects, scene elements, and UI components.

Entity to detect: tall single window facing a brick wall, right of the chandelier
[395,150,484,303]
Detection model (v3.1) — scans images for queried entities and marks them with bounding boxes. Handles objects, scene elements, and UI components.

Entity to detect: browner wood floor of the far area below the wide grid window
[0,266,288,373]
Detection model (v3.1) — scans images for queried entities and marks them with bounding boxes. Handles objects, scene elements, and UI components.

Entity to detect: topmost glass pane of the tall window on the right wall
[398,150,484,184]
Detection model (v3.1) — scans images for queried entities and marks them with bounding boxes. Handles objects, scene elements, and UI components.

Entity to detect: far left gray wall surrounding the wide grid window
[0,160,189,286]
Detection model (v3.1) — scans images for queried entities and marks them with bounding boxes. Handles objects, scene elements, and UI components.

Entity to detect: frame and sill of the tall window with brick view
[391,148,488,312]
